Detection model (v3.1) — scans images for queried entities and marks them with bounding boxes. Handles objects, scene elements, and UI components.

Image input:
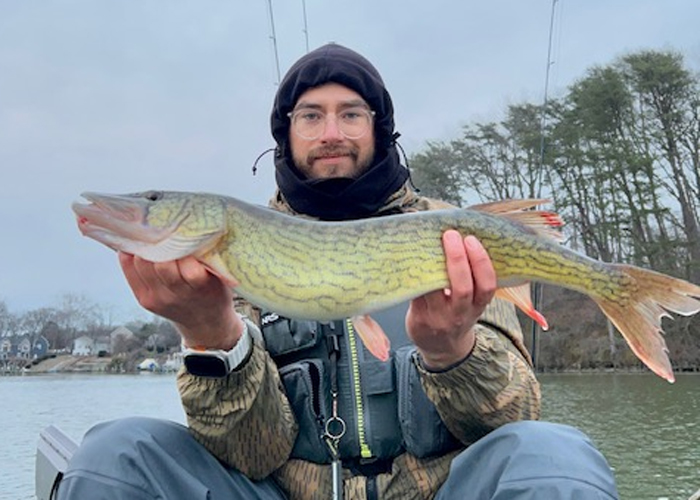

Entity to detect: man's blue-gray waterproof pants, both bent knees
[58,417,618,500]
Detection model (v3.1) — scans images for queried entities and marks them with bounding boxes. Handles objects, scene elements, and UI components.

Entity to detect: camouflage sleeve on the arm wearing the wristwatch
[178,323,298,480]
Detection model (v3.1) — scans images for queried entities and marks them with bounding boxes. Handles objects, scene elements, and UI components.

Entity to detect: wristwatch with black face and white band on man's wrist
[182,321,253,378]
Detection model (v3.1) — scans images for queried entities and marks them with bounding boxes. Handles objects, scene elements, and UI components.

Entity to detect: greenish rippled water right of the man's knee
[540,374,700,500]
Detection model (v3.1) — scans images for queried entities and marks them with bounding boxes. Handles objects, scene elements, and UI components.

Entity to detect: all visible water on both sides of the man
[0,374,700,500]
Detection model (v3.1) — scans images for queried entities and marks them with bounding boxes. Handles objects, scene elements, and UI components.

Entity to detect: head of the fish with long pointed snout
[72,191,226,262]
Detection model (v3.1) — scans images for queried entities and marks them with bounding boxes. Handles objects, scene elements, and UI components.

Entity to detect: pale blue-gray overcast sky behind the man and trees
[0,0,700,320]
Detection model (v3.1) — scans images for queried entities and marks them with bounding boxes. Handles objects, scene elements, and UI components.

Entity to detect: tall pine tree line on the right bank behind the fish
[409,50,700,370]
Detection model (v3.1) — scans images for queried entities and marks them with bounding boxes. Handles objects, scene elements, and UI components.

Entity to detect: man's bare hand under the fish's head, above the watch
[119,252,244,350]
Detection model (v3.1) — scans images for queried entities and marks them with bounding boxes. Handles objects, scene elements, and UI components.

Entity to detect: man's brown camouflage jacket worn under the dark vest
[178,186,540,500]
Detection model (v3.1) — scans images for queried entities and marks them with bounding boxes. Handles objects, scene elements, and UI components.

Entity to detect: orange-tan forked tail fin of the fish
[594,264,700,382]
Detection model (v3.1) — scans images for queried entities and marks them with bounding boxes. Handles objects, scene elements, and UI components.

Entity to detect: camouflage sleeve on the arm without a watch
[416,301,541,445]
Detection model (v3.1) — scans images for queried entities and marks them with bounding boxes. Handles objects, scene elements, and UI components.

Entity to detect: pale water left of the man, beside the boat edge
[0,374,185,500]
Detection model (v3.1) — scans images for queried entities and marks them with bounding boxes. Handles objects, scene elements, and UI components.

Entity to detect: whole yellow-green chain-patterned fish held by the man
[72,190,700,382]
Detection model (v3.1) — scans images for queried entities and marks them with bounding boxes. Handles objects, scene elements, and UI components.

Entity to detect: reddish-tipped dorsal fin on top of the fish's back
[470,198,564,243]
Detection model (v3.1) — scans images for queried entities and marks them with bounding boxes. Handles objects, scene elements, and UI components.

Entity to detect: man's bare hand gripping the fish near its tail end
[406,230,496,370]
